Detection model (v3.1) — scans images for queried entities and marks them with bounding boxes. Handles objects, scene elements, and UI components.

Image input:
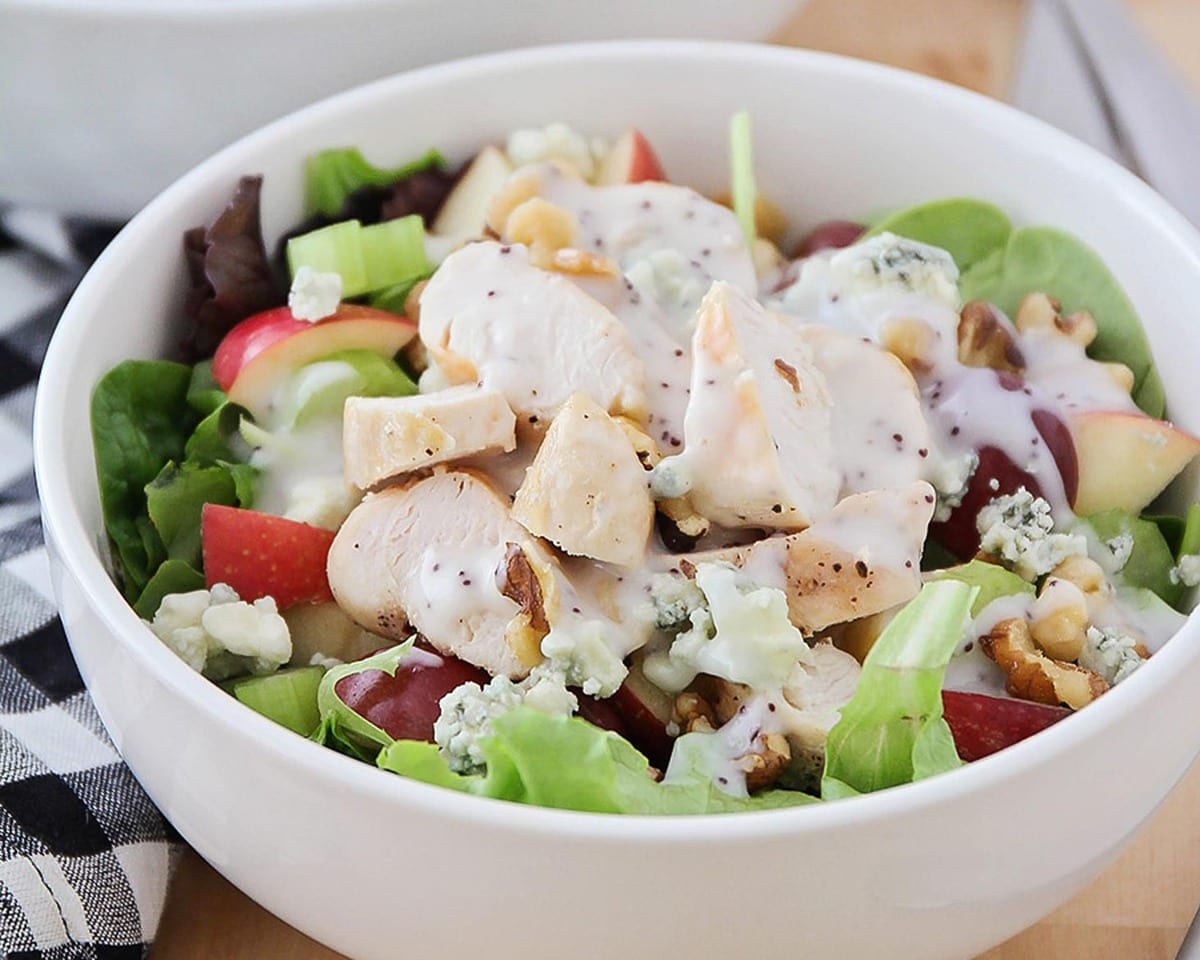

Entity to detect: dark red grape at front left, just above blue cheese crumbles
[334,646,491,743]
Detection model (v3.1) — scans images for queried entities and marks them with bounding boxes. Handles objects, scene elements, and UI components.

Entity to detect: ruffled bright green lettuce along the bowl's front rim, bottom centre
[378,707,816,814]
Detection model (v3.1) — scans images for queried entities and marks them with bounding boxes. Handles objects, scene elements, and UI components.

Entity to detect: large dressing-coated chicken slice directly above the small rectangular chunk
[420,241,646,427]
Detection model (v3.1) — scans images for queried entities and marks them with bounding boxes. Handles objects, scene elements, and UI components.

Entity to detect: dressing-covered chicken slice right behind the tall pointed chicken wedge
[796,324,930,497]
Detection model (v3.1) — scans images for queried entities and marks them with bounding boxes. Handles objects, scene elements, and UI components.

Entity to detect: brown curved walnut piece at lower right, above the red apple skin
[979,617,1109,710]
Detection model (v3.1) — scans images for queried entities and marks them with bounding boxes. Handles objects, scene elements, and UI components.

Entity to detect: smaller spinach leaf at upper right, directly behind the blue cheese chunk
[866,197,1013,272]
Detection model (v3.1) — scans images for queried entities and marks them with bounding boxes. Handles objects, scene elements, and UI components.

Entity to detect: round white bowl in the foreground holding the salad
[35,42,1200,960]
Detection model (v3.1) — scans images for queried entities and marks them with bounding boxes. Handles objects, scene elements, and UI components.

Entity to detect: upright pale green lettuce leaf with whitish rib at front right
[821,580,978,799]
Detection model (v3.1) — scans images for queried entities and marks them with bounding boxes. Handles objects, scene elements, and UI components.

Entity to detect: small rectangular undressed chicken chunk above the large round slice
[342,384,516,490]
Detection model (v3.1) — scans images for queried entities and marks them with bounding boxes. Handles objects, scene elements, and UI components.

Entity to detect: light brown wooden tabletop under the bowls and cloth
[154,0,1200,960]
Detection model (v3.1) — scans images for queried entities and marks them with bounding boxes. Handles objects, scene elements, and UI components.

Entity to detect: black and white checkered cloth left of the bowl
[0,211,178,960]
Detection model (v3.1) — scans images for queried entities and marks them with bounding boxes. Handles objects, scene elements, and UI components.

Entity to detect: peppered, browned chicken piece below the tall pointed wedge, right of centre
[674,481,935,636]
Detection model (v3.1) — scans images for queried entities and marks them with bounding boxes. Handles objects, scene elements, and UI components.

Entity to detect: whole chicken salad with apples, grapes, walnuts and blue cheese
[92,114,1200,814]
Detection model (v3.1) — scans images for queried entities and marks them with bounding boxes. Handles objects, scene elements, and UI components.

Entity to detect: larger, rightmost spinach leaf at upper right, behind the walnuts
[959,227,1164,416]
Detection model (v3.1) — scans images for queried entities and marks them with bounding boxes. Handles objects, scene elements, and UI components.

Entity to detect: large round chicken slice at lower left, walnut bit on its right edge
[328,472,560,679]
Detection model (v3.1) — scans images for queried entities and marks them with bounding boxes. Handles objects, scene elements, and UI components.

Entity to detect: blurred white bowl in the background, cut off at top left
[0,0,798,218]
